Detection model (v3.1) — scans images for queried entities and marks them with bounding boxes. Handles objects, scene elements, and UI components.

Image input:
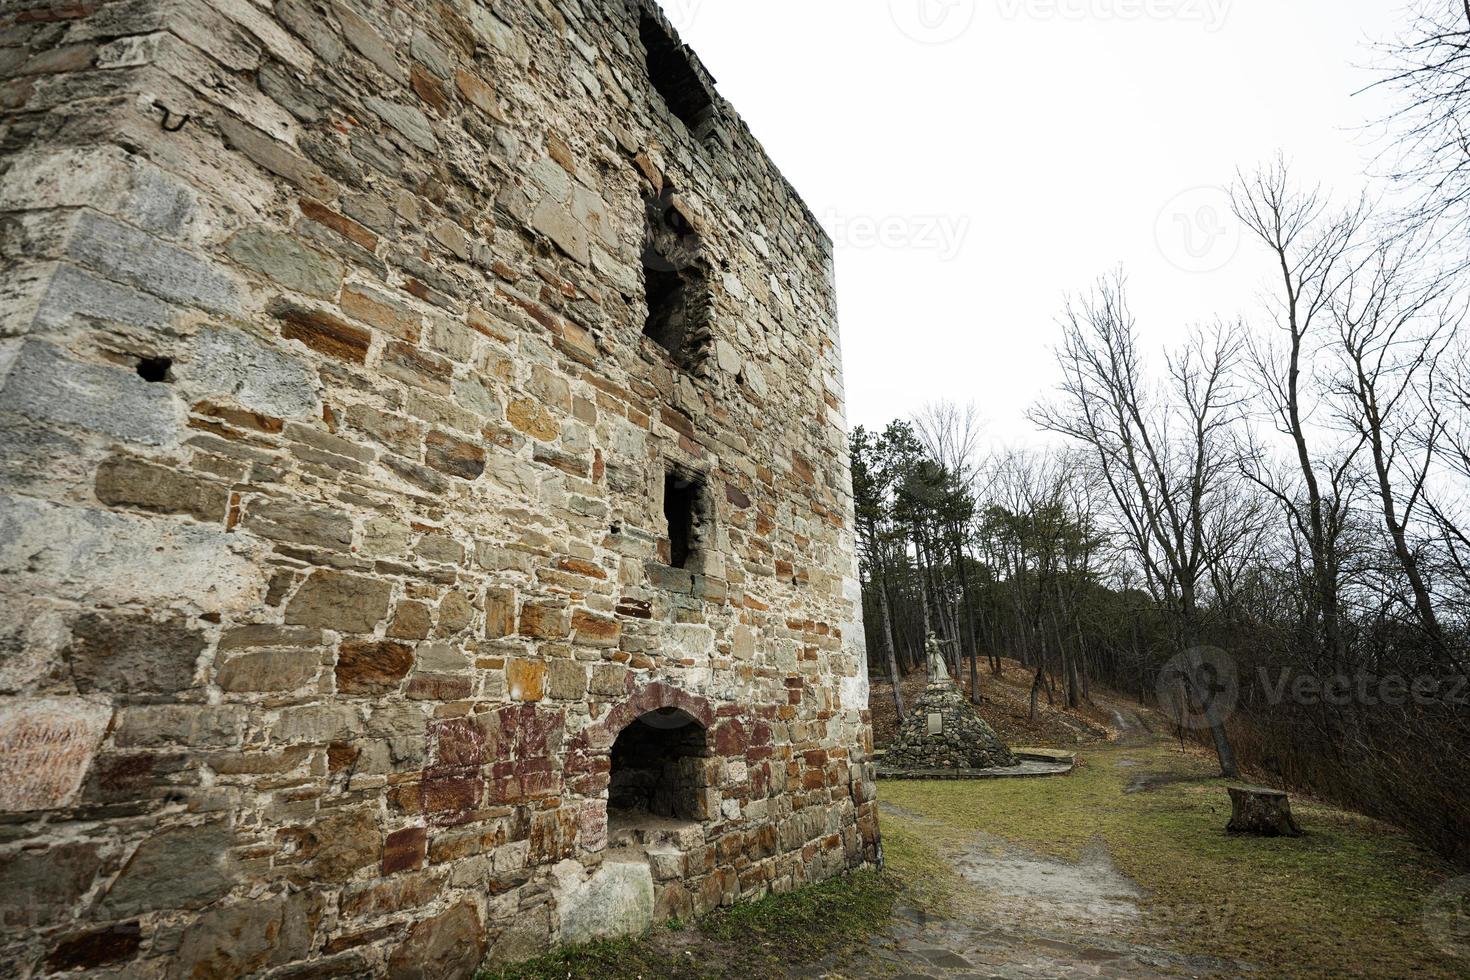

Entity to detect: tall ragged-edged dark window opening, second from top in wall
[642,187,713,372]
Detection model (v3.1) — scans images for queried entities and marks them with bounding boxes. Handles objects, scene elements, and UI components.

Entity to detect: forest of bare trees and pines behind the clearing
[853,0,1470,860]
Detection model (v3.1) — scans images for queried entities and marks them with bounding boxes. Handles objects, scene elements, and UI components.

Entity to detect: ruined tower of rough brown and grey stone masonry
[0,0,878,979]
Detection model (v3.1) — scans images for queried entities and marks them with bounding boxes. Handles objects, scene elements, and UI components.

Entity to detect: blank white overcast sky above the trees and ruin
[663,0,1404,445]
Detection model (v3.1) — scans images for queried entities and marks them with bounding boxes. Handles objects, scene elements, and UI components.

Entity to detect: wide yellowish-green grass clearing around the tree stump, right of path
[881,742,1470,977]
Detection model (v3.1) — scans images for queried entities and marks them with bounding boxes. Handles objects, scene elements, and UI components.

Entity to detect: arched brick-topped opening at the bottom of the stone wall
[607,708,711,846]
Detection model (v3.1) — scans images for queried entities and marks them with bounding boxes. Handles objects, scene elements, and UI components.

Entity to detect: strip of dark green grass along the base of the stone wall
[481,871,898,980]
